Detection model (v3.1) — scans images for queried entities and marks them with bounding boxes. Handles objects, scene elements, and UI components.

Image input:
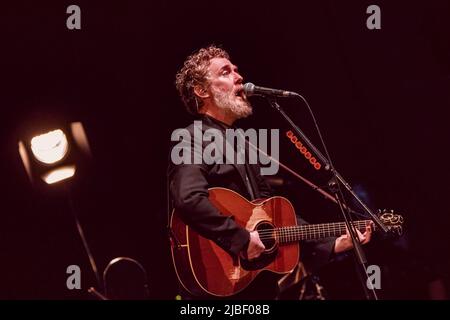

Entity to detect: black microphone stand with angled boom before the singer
[266,94,388,300]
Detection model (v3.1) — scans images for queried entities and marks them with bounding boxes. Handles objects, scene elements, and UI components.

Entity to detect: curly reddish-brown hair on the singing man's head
[175,45,230,115]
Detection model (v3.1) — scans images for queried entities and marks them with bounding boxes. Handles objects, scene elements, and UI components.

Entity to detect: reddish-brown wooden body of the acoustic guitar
[171,188,300,297]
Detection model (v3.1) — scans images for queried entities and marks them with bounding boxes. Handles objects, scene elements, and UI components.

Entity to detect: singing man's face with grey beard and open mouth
[207,58,252,119]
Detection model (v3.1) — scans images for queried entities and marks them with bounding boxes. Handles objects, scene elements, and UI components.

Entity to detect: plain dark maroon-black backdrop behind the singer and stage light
[0,0,450,299]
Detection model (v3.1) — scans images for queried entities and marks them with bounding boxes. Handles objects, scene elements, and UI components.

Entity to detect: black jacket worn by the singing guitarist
[168,116,334,267]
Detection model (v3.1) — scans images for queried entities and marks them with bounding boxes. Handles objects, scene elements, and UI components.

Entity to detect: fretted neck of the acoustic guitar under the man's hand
[274,220,371,243]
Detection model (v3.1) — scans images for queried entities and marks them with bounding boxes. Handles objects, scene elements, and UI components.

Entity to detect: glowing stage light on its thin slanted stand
[18,119,102,292]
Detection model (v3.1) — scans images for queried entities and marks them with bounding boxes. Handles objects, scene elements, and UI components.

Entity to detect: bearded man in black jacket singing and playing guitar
[168,46,371,298]
